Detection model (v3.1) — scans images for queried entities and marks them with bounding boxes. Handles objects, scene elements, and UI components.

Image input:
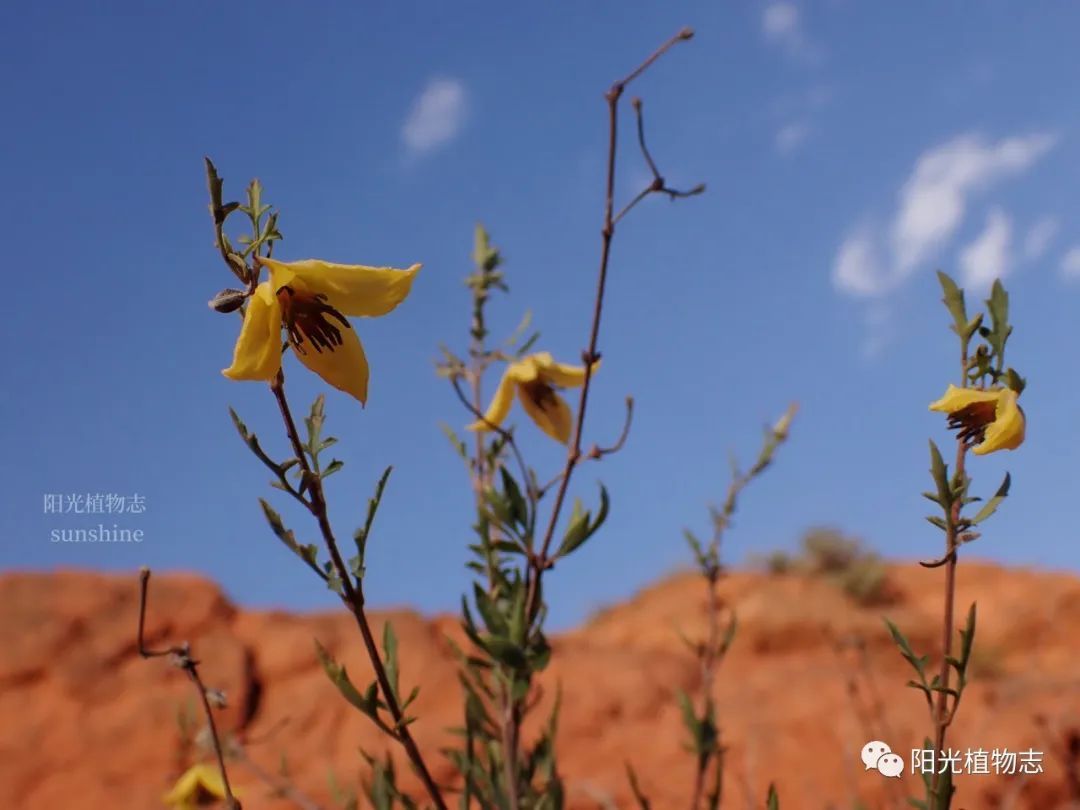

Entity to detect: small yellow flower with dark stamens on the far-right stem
[930,386,1026,456]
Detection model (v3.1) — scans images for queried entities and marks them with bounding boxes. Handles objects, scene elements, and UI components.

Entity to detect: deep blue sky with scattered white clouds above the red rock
[0,0,1080,626]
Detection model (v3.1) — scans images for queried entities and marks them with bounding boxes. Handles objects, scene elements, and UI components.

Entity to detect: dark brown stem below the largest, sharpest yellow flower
[270,369,446,810]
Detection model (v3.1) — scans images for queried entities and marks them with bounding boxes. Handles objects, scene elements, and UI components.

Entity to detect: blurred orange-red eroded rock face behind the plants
[0,561,1080,810]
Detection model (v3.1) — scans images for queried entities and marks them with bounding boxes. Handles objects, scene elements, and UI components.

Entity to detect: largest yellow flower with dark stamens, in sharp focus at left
[221,258,420,404]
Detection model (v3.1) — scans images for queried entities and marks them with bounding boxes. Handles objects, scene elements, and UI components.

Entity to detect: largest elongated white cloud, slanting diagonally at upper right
[833,134,1056,297]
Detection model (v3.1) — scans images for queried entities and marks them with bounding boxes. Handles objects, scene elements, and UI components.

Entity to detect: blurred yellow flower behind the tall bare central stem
[469,352,600,444]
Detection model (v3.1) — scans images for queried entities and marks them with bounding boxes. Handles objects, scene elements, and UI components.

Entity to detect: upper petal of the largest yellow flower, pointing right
[259,258,421,318]
